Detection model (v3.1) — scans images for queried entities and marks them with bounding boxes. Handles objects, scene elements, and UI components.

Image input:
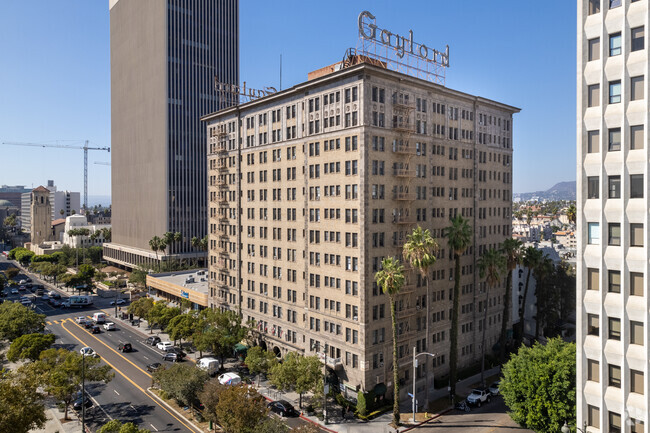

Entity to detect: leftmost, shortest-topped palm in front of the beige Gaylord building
[375,257,402,427]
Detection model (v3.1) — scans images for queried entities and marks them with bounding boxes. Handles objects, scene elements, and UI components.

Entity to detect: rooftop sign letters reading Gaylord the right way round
[359,11,449,66]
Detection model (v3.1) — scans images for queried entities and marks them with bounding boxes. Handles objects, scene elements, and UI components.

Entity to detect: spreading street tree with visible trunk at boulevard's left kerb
[34,349,114,419]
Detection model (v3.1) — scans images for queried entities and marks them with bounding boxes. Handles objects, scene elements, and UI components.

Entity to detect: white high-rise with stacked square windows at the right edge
[577,0,650,432]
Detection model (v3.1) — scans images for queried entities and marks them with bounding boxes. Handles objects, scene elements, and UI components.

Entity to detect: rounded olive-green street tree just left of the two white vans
[153,363,209,407]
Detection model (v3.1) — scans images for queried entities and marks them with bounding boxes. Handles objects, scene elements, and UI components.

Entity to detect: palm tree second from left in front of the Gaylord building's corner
[402,226,439,407]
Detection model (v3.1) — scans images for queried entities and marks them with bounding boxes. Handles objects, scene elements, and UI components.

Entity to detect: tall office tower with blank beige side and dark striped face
[104,0,239,268]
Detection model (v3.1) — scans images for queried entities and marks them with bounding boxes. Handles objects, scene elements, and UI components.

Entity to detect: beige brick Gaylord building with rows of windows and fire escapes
[203,63,519,401]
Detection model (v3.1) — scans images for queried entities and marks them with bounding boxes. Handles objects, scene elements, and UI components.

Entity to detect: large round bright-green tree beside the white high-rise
[499,338,576,433]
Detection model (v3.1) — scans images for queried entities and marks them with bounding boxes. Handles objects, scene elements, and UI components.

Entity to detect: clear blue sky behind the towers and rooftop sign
[0,0,576,195]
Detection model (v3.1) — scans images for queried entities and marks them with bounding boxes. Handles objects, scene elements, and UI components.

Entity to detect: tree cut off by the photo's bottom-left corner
[0,368,47,433]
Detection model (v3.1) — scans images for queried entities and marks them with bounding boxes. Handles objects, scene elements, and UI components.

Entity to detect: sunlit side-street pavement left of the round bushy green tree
[416,396,532,433]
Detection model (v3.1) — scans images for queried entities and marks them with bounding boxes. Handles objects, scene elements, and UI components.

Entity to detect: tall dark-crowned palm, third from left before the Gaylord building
[442,215,472,399]
